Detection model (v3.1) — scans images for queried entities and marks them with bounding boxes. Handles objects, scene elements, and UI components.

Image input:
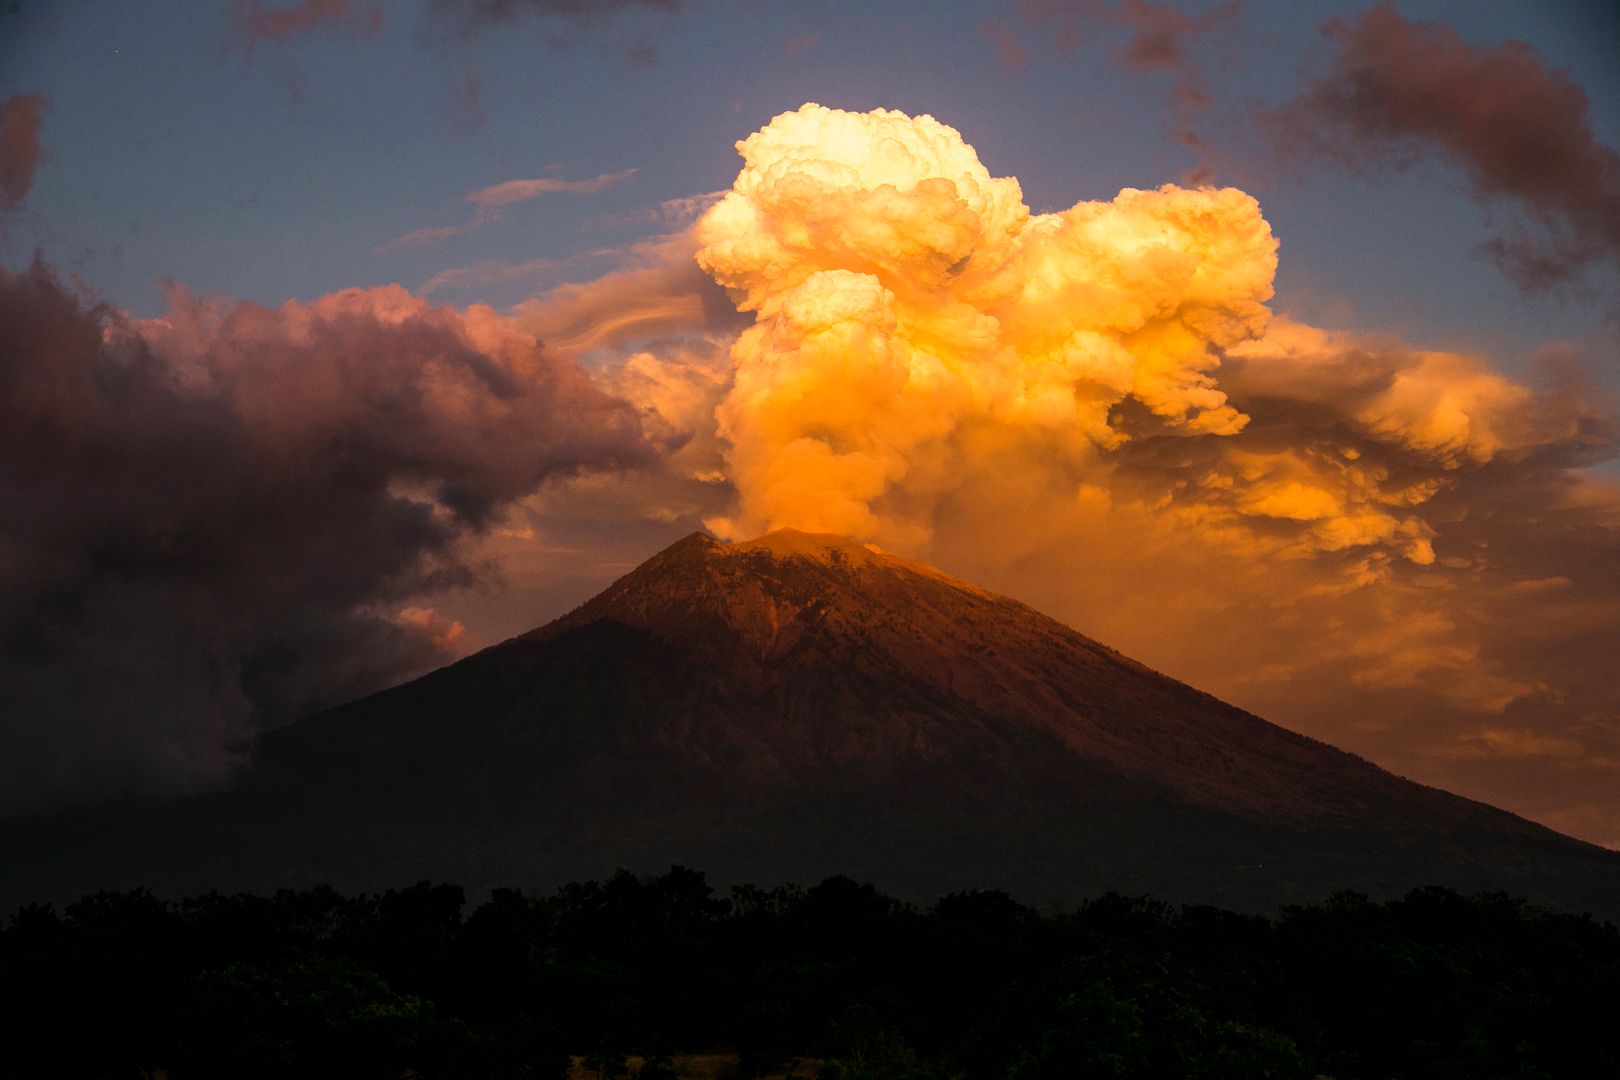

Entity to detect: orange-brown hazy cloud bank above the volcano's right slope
[926,319,1620,845]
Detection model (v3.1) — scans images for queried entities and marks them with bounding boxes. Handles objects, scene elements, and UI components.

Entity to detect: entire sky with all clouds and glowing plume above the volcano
[0,0,1620,847]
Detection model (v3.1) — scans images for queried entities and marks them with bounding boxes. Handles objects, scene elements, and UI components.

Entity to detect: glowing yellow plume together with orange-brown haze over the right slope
[664,105,1620,840]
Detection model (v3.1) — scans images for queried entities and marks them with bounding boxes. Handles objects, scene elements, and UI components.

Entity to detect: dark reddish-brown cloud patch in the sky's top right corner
[1265,5,1620,290]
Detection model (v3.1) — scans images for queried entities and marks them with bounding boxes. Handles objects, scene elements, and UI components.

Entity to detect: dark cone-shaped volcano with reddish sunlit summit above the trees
[13,531,1620,915]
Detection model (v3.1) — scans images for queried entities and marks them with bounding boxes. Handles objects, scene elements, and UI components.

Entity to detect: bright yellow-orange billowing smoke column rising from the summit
[698,104,1277,542]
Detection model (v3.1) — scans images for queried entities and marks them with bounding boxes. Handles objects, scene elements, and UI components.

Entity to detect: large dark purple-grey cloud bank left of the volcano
[0,261,663,813]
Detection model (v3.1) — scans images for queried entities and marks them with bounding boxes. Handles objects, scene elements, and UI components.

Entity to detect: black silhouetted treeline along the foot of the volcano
[0,868,1620,1080]
